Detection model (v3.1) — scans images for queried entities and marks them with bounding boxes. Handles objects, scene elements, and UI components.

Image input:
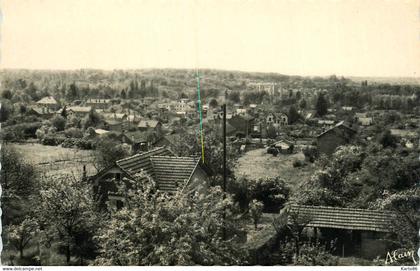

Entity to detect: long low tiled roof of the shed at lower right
[289,205,395,232]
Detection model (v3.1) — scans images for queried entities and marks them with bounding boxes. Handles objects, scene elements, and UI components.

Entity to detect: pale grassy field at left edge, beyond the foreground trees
[10,143,97,180]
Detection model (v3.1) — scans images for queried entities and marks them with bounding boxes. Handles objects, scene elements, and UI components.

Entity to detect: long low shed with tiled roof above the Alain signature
[286,205,396,259]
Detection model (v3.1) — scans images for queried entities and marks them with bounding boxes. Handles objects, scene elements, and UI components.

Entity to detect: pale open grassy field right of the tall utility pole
[234,149,314,189]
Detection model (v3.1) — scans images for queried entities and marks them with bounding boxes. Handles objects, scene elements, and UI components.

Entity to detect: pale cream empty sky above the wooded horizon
[0,0,420,77]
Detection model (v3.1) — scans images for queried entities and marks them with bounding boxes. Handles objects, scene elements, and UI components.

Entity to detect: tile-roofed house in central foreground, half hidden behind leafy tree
[90,148,209,208]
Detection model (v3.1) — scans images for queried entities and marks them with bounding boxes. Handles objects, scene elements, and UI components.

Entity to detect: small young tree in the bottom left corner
[6,217,38,259]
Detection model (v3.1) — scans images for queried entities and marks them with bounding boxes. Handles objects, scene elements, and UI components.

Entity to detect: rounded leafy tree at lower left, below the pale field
[38,175,100,264]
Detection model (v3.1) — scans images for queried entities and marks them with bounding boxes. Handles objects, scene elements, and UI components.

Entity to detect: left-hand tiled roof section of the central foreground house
[116,148,174,175]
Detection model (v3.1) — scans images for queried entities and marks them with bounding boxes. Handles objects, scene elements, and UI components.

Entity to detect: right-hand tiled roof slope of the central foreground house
[150,156,199,192]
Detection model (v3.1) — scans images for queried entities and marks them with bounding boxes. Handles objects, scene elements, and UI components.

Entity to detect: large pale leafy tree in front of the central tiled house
[96,180,245,265]
